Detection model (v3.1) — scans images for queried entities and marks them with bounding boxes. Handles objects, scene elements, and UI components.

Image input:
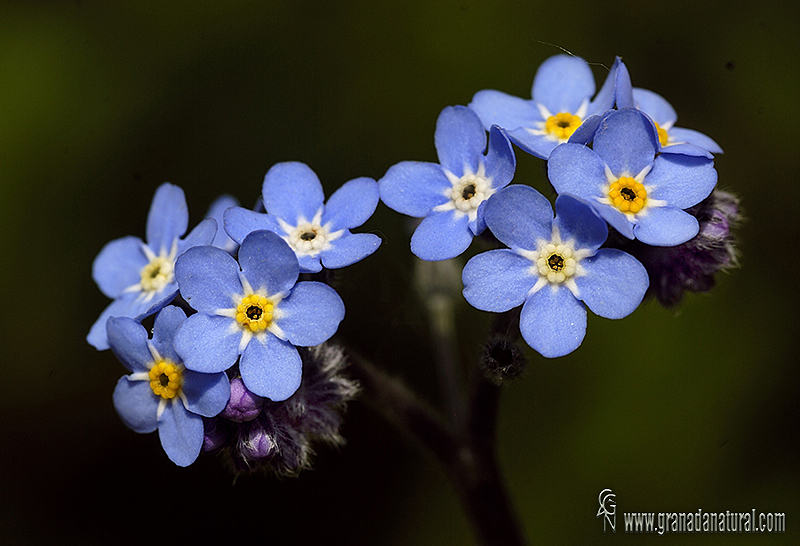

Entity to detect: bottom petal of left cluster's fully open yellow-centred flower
[239,334,303,402]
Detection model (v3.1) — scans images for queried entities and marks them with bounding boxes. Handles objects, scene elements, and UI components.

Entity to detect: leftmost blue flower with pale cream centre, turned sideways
[86,184,217,350]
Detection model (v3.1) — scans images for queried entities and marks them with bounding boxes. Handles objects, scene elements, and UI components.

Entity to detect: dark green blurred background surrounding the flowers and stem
[0,0,800,545]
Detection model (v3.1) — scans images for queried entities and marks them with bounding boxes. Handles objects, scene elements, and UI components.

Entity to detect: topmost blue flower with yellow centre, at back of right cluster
[469,55,629,159]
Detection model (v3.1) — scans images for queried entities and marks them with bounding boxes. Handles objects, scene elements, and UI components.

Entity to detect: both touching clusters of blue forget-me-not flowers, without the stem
[87,55,738,466]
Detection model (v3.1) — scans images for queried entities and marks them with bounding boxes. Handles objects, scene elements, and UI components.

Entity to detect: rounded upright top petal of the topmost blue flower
[533,55,595,115]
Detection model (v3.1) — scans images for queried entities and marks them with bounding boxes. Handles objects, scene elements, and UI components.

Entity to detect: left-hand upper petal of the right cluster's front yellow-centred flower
[547,142,608,202]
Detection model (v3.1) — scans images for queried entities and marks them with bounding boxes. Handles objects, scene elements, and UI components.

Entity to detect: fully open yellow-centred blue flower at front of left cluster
[175,231,344,401]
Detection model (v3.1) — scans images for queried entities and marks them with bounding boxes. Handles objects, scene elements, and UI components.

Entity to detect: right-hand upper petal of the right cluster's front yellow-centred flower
[645,153,717,209]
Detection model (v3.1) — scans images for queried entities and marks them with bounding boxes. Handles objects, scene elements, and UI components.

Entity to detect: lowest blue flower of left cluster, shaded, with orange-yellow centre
[108,306,230,466]
